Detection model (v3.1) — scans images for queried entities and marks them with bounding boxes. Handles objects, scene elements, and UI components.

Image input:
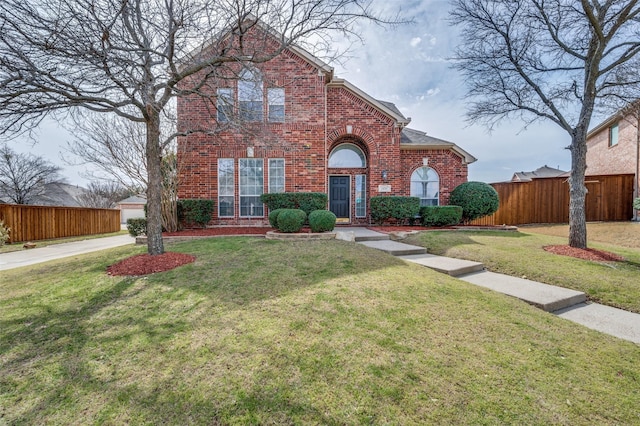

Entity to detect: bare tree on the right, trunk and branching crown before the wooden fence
[451,0,640,248]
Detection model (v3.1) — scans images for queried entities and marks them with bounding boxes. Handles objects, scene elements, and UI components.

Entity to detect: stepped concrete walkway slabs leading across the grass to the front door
[350,227,640,344]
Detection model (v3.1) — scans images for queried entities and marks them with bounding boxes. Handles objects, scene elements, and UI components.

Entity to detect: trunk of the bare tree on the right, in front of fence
[569,130,587,249]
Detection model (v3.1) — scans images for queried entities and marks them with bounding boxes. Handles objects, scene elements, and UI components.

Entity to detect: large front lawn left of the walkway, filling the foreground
[0,237,640,425]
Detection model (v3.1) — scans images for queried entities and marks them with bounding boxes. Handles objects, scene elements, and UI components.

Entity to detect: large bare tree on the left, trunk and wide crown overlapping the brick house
[0,0,394,255]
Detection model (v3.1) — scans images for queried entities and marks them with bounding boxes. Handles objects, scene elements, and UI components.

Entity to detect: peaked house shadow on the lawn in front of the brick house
[155,237,405,305]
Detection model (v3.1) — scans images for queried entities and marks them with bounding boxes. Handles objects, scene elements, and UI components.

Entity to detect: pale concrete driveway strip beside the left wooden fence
[0,235,135,271]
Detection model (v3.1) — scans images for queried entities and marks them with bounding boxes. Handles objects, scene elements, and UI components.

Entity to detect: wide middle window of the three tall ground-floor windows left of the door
[238,158,264,217]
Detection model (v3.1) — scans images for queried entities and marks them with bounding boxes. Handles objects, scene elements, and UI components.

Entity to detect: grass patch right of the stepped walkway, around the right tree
[406,224,640,313]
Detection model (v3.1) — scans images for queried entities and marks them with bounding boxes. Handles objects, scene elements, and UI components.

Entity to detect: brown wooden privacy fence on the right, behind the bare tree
[472,174,635,225]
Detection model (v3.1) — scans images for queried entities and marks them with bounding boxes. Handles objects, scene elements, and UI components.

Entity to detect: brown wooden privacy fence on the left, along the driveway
[0,204,120,242]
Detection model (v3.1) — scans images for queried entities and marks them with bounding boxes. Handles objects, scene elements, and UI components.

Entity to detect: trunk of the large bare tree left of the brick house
[146,111,164,255]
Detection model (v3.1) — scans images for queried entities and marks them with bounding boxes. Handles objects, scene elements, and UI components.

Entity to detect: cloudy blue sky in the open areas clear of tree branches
[6,0,576,186]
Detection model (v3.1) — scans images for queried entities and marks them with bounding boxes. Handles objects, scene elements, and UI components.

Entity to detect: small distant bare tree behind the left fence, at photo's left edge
[0,144,64,204]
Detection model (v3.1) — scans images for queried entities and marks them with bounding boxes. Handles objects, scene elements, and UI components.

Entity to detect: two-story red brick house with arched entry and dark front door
[178,20,476,225]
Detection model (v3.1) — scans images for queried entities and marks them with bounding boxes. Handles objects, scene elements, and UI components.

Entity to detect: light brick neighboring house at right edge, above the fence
[586,111,640,204]
